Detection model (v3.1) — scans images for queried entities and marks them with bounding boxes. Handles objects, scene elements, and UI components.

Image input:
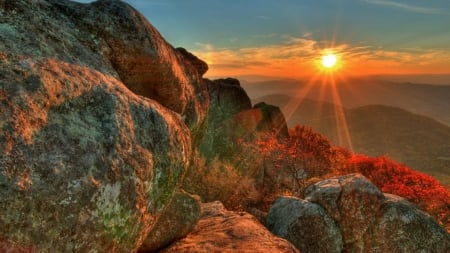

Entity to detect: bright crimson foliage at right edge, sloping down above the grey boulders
[346,155,450,231]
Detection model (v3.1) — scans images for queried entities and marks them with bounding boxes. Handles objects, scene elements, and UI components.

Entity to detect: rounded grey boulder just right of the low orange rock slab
[266,197,343,253]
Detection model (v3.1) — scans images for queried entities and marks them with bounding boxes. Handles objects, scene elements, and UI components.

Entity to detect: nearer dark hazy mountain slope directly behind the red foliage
[253,94,450,185]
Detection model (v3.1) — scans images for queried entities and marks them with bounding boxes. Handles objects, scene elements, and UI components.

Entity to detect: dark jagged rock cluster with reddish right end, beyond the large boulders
[199,78,288,158]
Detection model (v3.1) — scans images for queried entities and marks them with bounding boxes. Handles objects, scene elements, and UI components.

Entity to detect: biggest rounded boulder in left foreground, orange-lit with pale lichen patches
[0,58,191,252]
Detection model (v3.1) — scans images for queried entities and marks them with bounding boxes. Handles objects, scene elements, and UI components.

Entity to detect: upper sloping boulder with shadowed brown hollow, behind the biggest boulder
[0,0,209,130]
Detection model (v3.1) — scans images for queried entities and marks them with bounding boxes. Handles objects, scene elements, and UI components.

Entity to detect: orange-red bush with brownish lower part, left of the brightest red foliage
[251,126,350,200]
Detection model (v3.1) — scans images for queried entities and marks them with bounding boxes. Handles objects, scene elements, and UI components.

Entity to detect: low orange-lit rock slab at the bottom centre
[162,202,298,253]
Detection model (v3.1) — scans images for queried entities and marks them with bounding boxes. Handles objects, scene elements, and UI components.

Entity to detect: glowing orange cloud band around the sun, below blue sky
[193,37,450,78]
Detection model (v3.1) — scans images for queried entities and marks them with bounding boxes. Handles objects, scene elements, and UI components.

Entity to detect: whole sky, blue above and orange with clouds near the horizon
[74,0,450,78]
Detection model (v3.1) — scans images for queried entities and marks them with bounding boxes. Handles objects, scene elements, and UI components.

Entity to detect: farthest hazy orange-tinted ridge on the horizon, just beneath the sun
[243,78,450,126]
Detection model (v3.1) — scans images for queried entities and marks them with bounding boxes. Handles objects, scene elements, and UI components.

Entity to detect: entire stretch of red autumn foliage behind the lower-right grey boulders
[240,126,450,231]
